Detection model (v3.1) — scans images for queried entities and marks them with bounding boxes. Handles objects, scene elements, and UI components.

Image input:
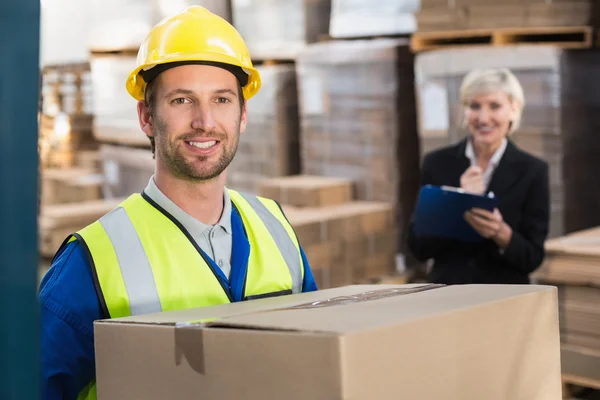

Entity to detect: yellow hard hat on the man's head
[126,6,261,100]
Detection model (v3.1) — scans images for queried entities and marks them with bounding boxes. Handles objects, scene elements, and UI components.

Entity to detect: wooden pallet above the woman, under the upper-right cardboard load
[411,26,594,53]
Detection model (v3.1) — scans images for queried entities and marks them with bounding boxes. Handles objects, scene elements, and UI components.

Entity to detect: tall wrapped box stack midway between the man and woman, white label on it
[297,39,419,253]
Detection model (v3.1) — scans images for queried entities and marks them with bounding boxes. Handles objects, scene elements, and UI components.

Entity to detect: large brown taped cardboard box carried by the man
[94,285,561,400]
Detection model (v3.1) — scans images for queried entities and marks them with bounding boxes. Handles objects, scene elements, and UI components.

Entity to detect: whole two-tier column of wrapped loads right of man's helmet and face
[227,0,331,194]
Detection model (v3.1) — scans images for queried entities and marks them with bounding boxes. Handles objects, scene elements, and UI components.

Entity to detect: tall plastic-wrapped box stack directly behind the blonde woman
[416,46,600,237]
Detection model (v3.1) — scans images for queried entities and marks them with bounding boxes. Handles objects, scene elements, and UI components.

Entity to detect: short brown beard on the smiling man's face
[153,116,240,182]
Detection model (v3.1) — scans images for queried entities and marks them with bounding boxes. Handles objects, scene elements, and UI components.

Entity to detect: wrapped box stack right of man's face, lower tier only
[227,64,300,194]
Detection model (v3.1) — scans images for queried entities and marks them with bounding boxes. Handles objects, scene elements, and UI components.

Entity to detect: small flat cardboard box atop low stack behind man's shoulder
[259,175,353,207]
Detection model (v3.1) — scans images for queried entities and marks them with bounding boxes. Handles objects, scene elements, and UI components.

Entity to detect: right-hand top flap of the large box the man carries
[205,285,556,334]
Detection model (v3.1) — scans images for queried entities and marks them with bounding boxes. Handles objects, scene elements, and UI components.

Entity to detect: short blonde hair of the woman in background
[460,68,525,135]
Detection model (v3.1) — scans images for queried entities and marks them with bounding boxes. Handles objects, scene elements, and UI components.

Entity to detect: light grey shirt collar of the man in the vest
[144,176,231,236]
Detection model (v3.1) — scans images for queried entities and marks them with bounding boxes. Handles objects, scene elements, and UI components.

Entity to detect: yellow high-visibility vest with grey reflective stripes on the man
[67,189,304,399]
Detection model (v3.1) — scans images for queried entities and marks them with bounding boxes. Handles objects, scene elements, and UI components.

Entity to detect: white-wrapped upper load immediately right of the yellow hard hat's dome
[231,0,331,60]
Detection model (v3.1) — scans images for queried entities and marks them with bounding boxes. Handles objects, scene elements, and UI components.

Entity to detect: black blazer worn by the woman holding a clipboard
[408,139,550,284]
